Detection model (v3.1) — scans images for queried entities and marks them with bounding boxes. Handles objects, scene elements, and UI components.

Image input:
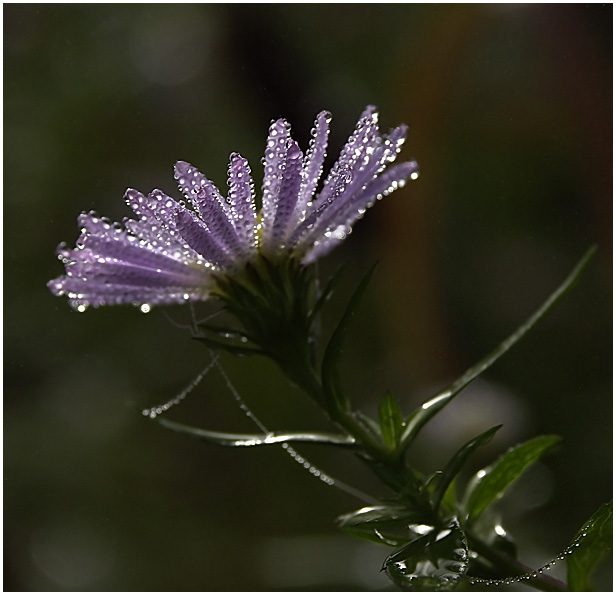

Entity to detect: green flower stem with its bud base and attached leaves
[157,248,611,591]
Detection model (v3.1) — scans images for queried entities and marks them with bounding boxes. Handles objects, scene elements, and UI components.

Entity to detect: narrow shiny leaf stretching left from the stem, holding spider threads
[154,417,356,448]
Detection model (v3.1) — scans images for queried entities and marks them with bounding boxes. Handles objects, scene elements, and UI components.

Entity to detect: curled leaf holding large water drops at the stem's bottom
[383,518,469,591]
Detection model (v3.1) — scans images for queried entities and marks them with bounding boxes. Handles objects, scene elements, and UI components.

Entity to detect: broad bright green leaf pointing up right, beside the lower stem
[464,436,560,523]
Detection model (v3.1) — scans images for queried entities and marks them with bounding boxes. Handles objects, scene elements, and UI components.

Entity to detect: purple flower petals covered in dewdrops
[48,107,418,311]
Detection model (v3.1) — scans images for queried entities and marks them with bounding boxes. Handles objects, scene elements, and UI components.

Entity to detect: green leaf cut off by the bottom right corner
[566,502,612,591]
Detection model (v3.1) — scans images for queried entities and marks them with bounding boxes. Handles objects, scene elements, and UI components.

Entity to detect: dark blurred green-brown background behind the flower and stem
[4,4,612,591]
